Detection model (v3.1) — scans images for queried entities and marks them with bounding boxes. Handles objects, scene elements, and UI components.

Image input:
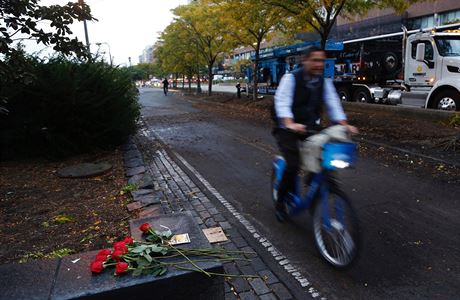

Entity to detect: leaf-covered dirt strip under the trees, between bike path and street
[174,94,460,183]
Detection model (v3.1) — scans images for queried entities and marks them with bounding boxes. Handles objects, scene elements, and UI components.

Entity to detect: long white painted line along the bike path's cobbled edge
[141,128,327,300]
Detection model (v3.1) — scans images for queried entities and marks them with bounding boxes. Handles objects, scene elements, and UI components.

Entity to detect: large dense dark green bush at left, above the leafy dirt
[0,53,139,157]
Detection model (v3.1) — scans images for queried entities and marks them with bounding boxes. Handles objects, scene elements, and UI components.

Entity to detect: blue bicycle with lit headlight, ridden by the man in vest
[272,143,360,268]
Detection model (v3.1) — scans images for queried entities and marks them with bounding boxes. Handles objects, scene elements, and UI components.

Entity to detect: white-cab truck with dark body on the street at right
[334,23,460,111]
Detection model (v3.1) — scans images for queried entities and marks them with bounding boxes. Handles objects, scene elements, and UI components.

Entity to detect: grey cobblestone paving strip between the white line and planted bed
[120,121,319,299]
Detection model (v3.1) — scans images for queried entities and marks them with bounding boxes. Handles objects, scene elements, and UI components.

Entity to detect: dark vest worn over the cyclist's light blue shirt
[292,68,324,128]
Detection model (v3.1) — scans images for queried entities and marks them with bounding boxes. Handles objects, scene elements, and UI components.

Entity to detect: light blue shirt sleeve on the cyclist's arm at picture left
[275,74,295,119]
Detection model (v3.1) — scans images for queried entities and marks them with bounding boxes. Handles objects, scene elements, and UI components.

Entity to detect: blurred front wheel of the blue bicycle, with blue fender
[313,190,360,269]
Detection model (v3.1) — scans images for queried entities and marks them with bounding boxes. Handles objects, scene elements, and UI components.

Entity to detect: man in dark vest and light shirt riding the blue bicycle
[274,46,358,221]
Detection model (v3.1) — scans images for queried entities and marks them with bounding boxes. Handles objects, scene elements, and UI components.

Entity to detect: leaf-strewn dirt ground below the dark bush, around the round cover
[0,150,131,263]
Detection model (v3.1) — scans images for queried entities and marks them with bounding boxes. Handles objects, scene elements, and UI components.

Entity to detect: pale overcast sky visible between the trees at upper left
[32,0,187,64]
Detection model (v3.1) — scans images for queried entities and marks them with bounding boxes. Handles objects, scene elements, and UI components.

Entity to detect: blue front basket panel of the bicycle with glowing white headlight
[322,143,356,170]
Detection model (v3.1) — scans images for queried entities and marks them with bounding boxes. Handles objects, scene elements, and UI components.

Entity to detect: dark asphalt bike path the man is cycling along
[141,89,460,299]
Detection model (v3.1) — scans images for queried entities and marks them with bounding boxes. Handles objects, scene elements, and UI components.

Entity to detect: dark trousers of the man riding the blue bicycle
[274,128,306,208]
